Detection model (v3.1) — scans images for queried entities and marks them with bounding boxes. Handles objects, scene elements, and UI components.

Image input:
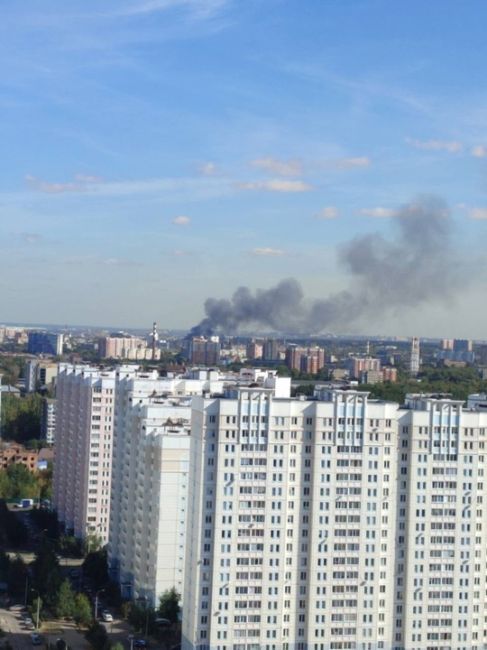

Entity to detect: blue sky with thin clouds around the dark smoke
[0,0,487,338]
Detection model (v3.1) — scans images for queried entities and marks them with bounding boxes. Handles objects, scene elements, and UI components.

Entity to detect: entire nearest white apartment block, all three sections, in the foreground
[183,388,487,650]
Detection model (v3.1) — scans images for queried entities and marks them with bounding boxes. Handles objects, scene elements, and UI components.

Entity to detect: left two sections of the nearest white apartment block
[183,388,397,650]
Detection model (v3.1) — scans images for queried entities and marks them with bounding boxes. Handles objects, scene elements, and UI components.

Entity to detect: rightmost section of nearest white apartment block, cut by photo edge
[393,395,487,650]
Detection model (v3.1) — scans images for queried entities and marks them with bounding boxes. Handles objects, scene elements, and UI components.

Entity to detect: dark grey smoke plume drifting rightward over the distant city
[192,197,461,335]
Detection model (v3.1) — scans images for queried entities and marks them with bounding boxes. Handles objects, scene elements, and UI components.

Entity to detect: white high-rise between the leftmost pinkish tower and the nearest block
[108,366,290,605]
